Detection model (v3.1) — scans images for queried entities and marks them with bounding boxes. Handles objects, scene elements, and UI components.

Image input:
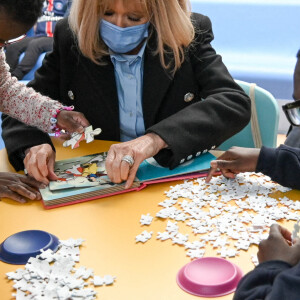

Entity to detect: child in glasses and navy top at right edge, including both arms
[206,51,300,300]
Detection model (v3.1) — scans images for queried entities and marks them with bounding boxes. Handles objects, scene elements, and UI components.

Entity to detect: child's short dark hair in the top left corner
[0,0,44,26]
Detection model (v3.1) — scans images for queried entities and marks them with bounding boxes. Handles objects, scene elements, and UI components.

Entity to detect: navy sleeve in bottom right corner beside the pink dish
[233,261,300,300]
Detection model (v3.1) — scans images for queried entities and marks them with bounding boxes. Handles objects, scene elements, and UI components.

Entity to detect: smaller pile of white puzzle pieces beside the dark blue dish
[6,239,116,300]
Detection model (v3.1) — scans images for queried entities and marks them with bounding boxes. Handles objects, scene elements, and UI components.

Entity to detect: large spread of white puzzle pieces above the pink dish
[136,173,300,264]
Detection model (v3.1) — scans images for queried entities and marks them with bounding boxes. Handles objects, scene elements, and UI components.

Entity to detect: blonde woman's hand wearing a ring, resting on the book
[105,133,167,189]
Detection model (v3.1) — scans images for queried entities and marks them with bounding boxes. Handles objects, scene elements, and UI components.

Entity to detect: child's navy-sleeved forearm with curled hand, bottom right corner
[233,224,300,300]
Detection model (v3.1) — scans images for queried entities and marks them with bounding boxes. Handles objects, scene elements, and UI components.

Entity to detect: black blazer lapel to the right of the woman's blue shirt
[143,40,173,129]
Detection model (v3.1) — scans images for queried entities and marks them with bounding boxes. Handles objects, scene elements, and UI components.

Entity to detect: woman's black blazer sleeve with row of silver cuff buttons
[146,15,251,169]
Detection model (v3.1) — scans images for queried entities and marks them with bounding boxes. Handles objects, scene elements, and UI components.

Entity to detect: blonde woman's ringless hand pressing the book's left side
[24,144,58,185]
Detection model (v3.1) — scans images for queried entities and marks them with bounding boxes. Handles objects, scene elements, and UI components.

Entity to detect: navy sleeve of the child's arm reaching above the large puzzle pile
[256,145,300,189]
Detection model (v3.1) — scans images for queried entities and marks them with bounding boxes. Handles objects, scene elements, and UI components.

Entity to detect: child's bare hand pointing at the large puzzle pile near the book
[206,147,260,182]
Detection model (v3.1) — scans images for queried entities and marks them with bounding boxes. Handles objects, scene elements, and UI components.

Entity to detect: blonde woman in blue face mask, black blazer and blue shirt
[3,0,250,188]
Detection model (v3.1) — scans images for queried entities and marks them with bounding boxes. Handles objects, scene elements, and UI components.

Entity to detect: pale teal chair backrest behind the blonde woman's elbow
[218,80,279,150]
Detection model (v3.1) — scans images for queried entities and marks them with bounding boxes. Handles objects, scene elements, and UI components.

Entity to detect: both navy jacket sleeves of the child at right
[233,145,300,300]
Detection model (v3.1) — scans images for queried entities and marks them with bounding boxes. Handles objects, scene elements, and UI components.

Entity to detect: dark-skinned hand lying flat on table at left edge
[0,172,45,203]
